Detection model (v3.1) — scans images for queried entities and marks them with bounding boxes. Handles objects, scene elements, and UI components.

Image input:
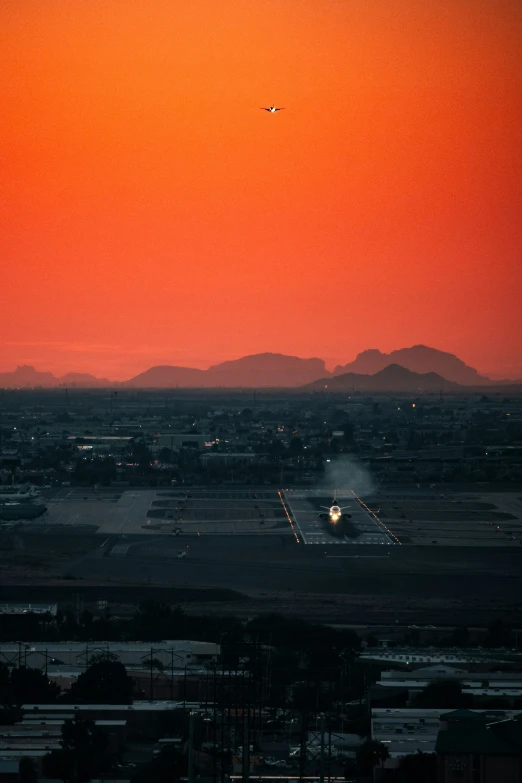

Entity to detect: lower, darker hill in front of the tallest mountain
[305,364,461,392]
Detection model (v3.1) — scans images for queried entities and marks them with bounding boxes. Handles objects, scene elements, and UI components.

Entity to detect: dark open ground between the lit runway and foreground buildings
[0,532,522,625]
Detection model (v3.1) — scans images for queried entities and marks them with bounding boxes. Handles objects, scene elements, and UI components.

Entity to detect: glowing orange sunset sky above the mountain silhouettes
[0,0,522,378]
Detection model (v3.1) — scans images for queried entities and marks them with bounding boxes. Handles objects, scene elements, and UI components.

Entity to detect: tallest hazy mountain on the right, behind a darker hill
[334,345,491,386]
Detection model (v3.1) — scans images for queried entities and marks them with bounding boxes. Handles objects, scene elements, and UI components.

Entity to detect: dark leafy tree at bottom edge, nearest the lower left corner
[43,715,107,783]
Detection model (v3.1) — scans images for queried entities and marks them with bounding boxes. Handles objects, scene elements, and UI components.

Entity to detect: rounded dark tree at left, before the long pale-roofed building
[69,659,134,704]
